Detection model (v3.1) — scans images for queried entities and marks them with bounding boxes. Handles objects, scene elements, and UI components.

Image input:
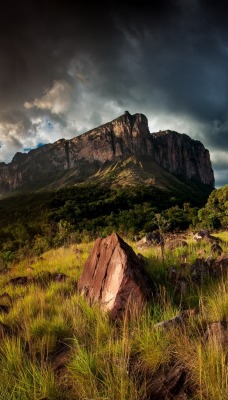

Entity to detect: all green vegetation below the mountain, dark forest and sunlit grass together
[0,183,228,400]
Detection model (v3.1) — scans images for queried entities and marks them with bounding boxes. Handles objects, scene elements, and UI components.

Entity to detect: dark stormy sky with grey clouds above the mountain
[0,0,228,187]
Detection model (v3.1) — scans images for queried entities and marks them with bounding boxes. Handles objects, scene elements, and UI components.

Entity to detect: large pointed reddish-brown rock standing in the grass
[78,233,152,319]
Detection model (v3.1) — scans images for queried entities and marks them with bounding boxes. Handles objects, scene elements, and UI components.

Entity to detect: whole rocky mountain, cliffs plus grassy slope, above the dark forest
[0,111,214,195]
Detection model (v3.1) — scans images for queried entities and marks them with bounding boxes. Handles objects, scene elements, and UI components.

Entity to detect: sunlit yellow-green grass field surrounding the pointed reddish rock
[0,233,228,400]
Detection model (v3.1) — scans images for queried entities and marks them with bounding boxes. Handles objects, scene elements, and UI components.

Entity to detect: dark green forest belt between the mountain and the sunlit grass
[0,183,210,268]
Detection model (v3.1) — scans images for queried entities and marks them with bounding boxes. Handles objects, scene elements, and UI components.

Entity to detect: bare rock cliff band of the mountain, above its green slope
[0,112,214,194]
